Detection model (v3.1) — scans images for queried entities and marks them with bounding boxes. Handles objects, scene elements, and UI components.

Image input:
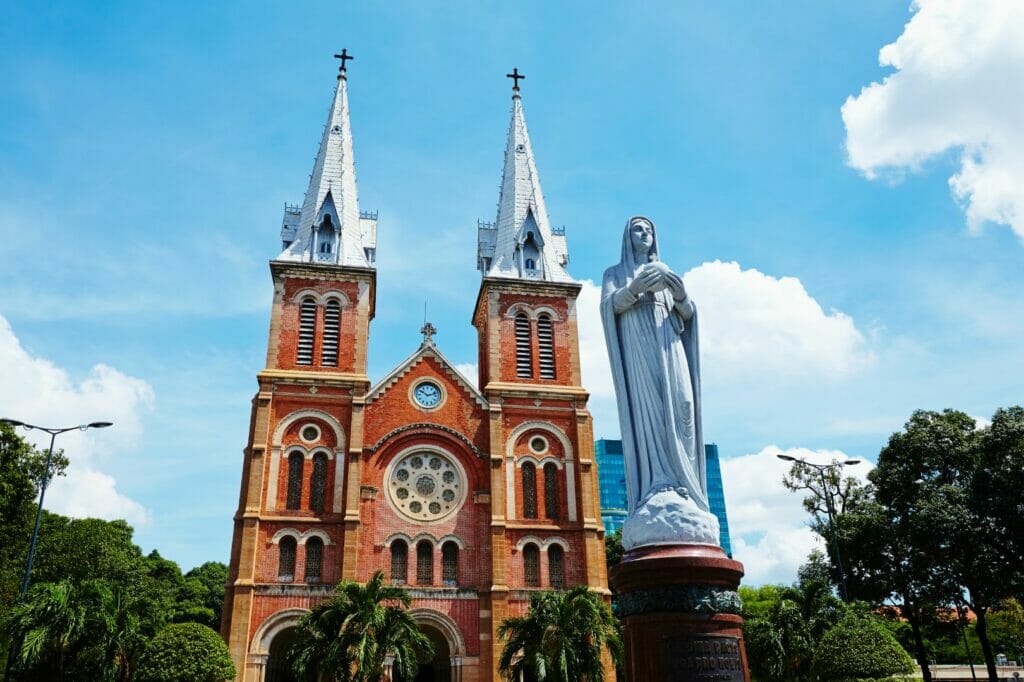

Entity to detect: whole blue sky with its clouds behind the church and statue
[0,0,1024,582]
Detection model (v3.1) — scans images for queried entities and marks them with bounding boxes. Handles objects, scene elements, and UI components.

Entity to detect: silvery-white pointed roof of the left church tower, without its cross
[278,65,376,267]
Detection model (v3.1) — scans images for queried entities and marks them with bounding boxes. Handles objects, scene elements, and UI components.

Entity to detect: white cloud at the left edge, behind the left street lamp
[0,315,154,523]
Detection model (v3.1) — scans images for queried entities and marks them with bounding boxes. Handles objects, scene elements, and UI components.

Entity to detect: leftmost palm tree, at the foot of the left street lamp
[0,581,86,679]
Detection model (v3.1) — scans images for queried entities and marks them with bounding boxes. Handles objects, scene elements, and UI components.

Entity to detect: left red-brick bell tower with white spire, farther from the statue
[221,51,377,680]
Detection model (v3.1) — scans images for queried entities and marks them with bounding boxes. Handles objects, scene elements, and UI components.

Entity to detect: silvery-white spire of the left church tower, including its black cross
[278,50,377,267]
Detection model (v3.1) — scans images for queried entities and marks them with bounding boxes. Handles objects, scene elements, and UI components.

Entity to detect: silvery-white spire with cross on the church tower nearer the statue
[477,69,572,282]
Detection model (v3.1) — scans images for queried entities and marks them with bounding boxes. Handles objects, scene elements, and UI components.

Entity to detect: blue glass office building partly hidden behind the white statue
[594,438,732,557]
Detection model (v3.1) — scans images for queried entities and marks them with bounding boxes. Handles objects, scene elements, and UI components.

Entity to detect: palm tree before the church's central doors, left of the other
[289,570,433,682]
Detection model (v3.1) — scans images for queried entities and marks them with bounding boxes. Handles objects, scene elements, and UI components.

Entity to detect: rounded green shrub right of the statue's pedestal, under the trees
[813,612,913,682]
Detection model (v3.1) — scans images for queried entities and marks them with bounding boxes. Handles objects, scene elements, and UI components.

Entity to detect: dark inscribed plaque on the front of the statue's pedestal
[663,635,746,682]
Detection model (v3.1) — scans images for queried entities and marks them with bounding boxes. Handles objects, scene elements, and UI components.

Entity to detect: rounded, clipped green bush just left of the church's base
[135,623,236,682]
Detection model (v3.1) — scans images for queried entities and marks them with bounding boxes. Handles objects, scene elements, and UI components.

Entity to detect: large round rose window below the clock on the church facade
[386,451,466,521]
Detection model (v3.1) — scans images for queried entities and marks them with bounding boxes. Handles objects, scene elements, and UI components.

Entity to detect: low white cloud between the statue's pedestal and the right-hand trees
[722,445,872,585]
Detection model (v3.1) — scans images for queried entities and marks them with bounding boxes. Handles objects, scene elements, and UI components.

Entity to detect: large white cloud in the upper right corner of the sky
[842,0,1024,239]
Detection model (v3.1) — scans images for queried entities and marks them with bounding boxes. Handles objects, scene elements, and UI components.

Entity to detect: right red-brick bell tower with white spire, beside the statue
[473,69,608,679]
